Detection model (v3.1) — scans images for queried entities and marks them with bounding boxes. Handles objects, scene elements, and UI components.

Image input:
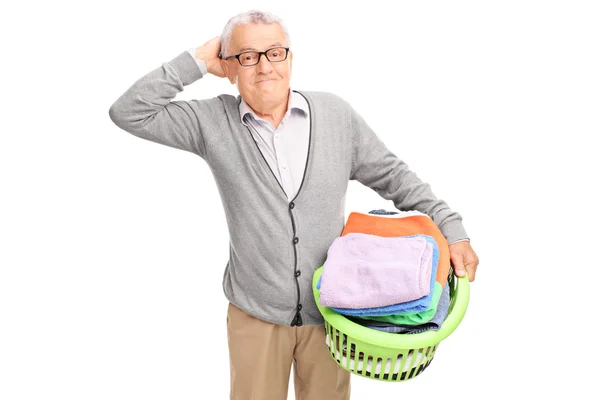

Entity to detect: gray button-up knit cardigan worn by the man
[109,52,467,326]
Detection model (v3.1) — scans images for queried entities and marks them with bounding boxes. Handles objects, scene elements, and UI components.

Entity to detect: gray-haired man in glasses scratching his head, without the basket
[109,10,479,400]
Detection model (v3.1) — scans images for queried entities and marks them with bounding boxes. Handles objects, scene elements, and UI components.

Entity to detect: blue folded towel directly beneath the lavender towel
[317,235,440,317]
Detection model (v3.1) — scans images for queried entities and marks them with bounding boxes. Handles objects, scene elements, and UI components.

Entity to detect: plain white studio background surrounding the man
[0,0,600,400]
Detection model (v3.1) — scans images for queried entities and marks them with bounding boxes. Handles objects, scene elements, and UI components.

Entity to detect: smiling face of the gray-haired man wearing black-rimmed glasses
[221,23,292,112]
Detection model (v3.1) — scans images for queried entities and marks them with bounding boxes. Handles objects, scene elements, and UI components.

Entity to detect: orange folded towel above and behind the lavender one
[341,212,450,288]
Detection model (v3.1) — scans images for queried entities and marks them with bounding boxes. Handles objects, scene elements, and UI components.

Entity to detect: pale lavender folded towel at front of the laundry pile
[320,233,433,308]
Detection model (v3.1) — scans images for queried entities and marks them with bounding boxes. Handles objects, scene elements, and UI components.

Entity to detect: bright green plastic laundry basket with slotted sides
[313,267,469,382]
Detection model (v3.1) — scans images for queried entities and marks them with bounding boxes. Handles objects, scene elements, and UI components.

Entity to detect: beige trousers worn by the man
[227,303,350,400]
